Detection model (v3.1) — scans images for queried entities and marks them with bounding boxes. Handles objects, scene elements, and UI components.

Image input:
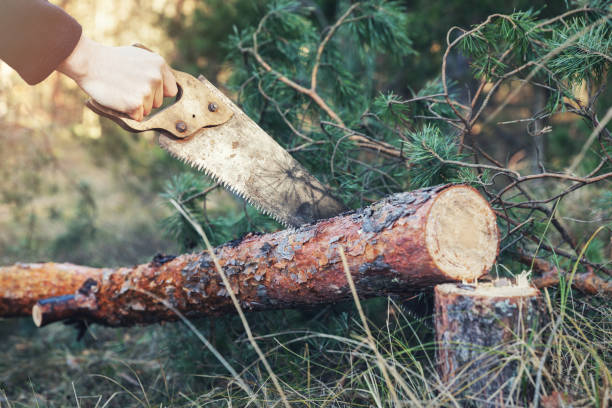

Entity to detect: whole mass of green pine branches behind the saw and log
[167,0,612,278]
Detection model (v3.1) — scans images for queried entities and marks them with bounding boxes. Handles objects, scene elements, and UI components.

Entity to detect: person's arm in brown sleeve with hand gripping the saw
[0,0,177,120]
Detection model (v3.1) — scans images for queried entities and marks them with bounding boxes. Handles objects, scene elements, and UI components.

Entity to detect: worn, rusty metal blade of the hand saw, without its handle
[159,77,345,226]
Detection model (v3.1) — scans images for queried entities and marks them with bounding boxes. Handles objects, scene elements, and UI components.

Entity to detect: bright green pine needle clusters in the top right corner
[461,6,612,93]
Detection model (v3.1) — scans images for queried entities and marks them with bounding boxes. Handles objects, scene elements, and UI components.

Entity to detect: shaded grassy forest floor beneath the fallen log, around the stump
[0,291,612,407]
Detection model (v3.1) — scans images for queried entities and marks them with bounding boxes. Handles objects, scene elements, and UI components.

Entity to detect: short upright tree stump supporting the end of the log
[434,280,540,407]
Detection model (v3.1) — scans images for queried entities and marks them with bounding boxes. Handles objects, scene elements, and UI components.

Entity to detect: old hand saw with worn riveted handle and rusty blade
[87,70,345,226]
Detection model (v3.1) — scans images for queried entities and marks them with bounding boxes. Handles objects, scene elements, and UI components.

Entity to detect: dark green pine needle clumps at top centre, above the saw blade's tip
[229,1,414,122]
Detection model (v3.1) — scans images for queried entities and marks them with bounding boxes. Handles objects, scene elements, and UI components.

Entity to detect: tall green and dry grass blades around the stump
[58,270,612,408]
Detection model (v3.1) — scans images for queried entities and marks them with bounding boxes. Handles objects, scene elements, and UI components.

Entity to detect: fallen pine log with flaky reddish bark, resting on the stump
[0,185,499,326]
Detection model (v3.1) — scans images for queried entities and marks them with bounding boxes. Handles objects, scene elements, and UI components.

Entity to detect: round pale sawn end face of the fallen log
[426,186,499,281]
